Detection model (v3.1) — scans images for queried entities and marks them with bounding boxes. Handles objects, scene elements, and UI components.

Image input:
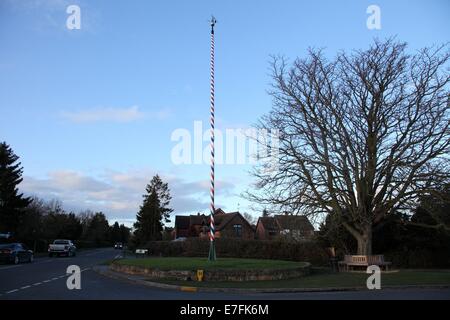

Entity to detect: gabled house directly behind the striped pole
[173,209,255,239]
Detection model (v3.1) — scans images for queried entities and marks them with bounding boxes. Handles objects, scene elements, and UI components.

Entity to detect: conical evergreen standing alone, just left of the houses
[134,175,173,244]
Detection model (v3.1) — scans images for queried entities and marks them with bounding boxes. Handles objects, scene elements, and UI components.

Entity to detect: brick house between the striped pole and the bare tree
[256,215,314,240]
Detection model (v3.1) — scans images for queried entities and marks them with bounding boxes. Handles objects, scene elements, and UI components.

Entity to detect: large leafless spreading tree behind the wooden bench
[247,39,450,254]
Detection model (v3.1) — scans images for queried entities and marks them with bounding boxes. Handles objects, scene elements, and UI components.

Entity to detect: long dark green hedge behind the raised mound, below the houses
[144,238,328,265]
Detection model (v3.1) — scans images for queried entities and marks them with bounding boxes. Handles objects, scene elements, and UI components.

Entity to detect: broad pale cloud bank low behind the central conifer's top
[20,170,235,224]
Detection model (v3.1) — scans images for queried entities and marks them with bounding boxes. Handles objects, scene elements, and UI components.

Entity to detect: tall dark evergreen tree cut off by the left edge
[0,142,31,233]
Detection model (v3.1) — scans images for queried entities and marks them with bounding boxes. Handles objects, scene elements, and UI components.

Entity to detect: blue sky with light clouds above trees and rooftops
[0,0,450,222]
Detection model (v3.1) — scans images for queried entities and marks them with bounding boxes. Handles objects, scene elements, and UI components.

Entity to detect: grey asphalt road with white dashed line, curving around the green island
[0,249,450,300]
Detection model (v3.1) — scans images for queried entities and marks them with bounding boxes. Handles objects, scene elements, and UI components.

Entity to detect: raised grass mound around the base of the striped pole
[116,257,305,270]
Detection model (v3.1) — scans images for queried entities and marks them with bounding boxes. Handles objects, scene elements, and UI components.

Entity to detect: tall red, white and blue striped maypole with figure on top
[208,16,217,261]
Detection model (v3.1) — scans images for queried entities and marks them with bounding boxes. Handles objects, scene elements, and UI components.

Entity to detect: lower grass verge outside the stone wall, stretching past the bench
[149,269,450,289]
